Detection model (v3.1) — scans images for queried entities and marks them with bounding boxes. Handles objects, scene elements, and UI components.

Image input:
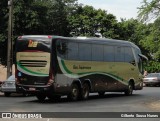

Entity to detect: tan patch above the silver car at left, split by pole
[0,64,15,81]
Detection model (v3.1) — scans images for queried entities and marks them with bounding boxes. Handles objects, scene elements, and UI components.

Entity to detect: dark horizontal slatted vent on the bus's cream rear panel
[19,60,47,67]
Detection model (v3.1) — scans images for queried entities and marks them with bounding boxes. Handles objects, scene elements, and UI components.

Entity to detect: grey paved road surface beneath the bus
[0,87,160,121]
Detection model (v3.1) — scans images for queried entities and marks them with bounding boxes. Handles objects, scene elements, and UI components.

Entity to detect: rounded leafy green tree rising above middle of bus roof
[68,5,117,38]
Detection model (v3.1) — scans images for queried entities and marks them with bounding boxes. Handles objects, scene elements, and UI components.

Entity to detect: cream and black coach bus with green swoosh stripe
[15,35,147,101]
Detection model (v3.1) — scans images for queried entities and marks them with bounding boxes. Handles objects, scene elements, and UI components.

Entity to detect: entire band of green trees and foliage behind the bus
[0,0,160,72]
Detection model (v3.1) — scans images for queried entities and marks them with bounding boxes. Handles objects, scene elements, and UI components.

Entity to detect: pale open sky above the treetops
[78,0,143,21]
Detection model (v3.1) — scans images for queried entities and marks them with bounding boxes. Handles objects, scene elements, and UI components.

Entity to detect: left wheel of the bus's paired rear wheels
[68,83,80,101]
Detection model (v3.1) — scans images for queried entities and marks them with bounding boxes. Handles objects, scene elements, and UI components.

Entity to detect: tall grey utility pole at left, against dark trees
[7,0,13,77]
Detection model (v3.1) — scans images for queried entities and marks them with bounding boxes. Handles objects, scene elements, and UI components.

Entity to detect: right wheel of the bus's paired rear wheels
[81,83,90,100]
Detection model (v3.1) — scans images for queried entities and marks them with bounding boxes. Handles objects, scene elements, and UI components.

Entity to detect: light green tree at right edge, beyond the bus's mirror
[138,0,160,72]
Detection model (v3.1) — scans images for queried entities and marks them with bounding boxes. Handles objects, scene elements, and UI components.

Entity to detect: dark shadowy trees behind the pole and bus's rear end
[0,0,77,65]
